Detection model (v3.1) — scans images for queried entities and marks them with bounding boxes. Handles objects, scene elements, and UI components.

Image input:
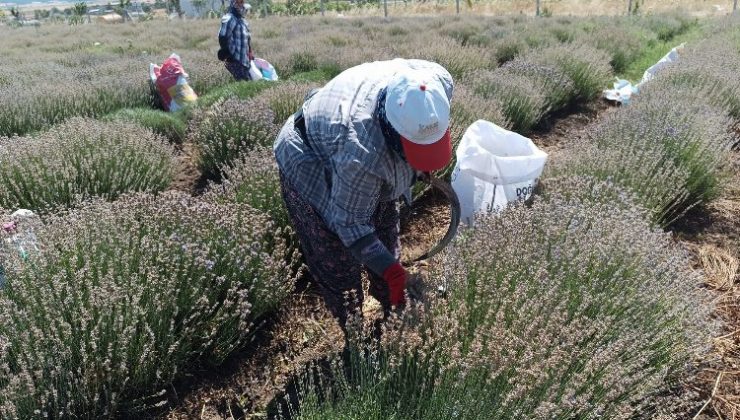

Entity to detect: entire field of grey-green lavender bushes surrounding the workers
[0,9,740,419]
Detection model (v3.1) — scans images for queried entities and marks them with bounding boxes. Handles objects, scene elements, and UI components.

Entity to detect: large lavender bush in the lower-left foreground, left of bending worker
[0,193,297,419]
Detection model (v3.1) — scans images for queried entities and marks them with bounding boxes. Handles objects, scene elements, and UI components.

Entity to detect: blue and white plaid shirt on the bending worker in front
[274,59,453,247]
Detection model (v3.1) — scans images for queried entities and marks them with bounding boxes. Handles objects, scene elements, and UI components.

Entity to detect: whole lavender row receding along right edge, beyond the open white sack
[545,18,740,226]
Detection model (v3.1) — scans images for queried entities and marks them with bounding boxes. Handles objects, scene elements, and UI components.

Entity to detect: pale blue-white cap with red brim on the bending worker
[385,69,452,172]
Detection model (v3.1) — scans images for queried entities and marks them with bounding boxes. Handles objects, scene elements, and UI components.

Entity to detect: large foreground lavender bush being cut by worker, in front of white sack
[290,196,711,419]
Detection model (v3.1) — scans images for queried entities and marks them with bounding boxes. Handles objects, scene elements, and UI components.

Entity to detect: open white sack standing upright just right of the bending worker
[452,120,547,226]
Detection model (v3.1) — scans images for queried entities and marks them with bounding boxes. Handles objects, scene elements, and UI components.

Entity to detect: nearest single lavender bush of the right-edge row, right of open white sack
[544,85,733,226]
